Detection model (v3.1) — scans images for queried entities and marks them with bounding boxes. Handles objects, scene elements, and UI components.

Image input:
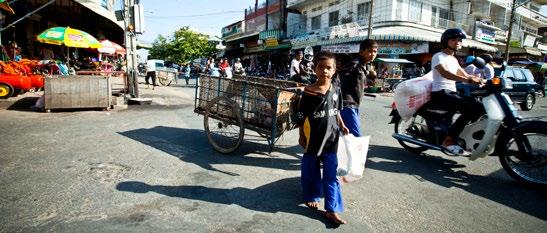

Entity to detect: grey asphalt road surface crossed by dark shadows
[0,79,547,232]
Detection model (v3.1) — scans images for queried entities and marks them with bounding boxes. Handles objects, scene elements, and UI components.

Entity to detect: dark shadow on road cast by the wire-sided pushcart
[118,126,300,176]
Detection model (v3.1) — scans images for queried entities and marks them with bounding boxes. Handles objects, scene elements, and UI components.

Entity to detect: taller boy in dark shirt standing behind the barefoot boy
[340,39,378,137]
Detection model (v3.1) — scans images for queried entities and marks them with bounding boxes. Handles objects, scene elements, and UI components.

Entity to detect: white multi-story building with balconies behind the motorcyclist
[287,0,547,62]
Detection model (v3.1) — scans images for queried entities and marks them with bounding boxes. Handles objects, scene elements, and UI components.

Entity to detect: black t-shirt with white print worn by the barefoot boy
[298,83,342,155]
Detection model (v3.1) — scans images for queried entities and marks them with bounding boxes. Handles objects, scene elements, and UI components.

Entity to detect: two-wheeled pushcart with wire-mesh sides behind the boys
[194,74,304,153]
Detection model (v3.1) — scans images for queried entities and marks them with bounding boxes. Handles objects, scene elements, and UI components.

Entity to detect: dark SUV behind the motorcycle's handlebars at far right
[494,66,542,111]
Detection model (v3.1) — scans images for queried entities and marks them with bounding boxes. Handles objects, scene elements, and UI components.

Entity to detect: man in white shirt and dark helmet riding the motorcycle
[431,28,484,155]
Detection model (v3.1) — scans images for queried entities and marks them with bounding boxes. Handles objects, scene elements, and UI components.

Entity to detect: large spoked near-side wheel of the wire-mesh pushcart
[203,96,245,154]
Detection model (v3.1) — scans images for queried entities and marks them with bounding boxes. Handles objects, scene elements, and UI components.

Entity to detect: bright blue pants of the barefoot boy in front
[301,153,344,213]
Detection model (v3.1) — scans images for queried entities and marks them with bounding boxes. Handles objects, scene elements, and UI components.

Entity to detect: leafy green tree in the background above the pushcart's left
[150,27,217,63]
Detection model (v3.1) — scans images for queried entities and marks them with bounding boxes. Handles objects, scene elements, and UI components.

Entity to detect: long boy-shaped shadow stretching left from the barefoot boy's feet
[116,177,337,228]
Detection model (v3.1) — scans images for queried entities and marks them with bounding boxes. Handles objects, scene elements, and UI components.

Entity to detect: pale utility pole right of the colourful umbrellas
[123,0,139,98]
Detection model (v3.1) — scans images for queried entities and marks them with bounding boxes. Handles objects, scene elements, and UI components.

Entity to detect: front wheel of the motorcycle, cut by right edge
[496,121,547,187]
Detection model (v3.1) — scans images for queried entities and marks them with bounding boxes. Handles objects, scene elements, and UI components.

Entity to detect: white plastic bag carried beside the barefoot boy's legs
[336,134,370,183]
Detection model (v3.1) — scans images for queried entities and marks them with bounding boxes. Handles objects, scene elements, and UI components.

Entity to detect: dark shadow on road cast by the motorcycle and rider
[366,146,547,220]
